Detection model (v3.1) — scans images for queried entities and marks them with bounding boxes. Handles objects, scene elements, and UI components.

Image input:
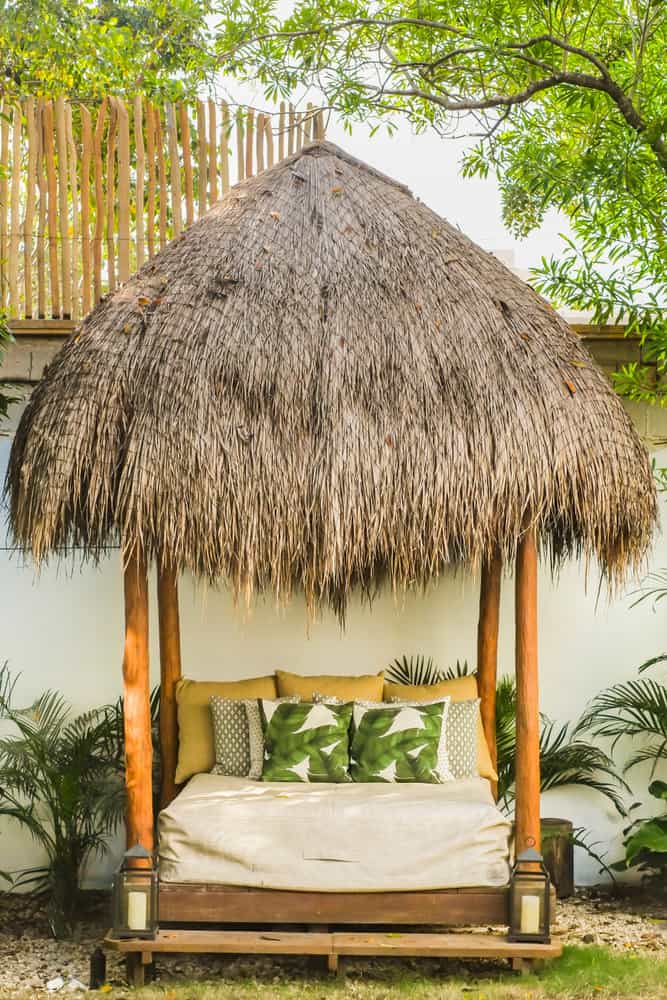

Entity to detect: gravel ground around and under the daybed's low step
[0,890,667,997]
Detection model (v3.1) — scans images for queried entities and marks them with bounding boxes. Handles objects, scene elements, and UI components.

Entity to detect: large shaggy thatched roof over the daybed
[8,143,656,609]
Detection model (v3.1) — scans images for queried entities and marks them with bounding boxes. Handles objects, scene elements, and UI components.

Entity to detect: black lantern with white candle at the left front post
[112,844,158,939]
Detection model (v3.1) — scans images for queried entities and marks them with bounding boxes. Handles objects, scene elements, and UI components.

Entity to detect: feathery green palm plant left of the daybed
[0,664,125,937]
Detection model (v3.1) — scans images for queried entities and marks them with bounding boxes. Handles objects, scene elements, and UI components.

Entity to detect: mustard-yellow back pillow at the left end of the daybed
[176,677,277,785]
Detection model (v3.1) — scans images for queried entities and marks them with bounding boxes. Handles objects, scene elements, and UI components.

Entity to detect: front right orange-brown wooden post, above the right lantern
[515,527,540,853]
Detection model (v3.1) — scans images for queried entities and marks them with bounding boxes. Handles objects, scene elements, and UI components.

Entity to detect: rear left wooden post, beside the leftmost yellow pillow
[158,566,181,809]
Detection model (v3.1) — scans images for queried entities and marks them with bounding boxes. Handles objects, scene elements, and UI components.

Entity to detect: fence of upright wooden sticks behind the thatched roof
[0,95,324,320]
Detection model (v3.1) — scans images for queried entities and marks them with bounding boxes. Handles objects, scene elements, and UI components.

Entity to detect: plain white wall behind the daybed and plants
[0,407,667,883]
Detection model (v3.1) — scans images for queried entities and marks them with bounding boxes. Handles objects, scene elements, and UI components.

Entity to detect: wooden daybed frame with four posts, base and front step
[113,528,560,971]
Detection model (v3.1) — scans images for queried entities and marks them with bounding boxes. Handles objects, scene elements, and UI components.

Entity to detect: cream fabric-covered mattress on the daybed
[159,774,510,892]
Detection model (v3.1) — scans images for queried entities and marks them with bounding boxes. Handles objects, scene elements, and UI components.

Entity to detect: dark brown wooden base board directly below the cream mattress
[160,882,508,925]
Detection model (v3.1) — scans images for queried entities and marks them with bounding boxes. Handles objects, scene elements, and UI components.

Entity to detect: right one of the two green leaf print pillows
[350,701,447,784]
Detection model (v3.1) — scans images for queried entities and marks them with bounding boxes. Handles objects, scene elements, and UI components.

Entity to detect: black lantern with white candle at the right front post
[508,847,551,944]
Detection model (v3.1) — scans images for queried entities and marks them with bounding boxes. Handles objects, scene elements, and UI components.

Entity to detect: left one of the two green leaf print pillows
[260,699,352,782]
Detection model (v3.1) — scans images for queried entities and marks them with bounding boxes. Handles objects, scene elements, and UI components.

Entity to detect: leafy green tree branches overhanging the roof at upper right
[217,0,667,404]
